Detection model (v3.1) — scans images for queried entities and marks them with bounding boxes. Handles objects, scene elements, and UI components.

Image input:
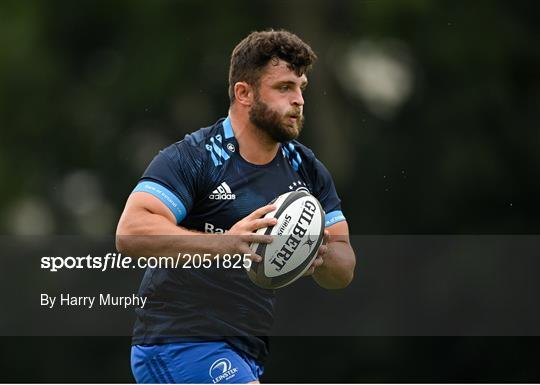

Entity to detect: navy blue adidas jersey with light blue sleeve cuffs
[133,118,345,360]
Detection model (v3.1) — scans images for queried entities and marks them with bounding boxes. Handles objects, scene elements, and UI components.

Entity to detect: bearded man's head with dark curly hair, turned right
[229,30,317,142]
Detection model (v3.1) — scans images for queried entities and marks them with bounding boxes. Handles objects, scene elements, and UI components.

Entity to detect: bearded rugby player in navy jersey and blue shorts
[117,30,355,383]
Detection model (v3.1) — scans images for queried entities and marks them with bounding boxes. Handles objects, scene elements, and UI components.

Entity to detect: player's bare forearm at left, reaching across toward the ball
[116,211,223,257]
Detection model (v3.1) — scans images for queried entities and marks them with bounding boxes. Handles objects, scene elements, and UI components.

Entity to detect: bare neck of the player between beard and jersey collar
[229,107,279,165]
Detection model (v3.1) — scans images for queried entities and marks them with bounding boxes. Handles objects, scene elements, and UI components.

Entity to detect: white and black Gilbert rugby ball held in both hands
[247,191,324,289]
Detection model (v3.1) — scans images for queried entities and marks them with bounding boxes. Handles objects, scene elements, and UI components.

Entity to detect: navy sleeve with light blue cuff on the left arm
[133,141,202,224]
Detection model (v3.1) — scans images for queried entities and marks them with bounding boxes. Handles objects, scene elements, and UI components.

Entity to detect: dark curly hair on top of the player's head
[229,29,317,103]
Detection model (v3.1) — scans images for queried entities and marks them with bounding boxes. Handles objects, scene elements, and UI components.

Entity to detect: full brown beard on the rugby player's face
[249,95,304,143]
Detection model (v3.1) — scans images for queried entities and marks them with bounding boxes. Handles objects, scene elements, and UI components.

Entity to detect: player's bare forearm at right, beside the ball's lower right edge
[313,241,356,289]
